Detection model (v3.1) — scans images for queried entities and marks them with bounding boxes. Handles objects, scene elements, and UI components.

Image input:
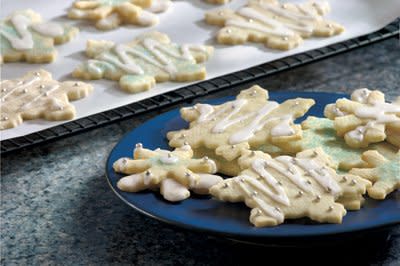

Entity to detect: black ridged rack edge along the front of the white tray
[1,18,400,154]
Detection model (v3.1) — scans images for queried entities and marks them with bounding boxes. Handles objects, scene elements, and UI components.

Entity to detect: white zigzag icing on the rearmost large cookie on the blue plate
[192,99,295,144]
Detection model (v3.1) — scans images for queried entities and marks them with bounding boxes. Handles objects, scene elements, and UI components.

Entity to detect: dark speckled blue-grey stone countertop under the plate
[1,39,400,265]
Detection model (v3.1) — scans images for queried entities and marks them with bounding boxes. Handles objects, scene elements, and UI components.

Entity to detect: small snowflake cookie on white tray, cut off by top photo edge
[68,0,171,30]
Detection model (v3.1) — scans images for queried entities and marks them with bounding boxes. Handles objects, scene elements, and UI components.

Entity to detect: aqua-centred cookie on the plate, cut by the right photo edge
[350,151,400,200]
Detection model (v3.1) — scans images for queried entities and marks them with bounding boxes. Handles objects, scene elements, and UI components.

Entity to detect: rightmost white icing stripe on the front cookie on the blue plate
[295,158,342,196]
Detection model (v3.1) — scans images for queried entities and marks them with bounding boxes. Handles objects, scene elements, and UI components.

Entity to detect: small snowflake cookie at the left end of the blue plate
[113,143,222,201]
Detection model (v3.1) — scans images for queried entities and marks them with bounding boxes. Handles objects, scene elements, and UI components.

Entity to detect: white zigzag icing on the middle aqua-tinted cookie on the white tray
[88,38,206,77]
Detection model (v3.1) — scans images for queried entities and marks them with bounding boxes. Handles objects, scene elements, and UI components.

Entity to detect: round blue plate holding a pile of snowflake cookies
[106,92,400,239]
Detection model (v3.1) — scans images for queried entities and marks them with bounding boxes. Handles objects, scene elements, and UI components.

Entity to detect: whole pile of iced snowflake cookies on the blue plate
[114,86,400,227]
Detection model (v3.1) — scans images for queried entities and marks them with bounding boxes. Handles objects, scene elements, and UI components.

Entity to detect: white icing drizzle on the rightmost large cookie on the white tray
[225,1,329,37]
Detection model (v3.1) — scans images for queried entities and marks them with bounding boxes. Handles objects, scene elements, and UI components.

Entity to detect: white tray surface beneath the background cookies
[0,0,400,140]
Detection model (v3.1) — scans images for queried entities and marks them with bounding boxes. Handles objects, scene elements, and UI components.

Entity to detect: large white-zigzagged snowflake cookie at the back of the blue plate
[167,85,314,161]
